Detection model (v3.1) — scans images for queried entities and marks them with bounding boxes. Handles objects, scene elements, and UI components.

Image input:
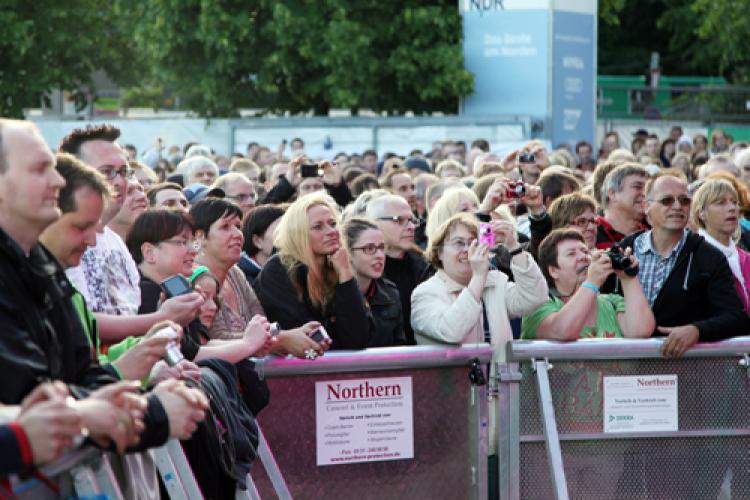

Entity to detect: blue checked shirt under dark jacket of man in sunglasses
[633,229,688,307]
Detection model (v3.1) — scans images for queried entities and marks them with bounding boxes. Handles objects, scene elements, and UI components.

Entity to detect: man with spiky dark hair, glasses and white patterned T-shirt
[60,124,202,342]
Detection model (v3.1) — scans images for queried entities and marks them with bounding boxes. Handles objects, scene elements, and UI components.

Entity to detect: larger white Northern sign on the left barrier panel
[315,377,414,465]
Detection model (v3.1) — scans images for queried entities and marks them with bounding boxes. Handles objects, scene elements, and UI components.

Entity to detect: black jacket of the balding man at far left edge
[0,230,169,449]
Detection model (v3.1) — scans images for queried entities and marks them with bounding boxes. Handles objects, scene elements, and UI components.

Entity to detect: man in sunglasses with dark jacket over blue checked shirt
[619,171,750,357]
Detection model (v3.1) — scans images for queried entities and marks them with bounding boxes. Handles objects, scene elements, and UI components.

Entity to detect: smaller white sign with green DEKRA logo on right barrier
[603,375,679,432]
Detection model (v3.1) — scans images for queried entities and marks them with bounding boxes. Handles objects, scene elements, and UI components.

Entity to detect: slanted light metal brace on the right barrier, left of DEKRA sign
[534,359,568,500]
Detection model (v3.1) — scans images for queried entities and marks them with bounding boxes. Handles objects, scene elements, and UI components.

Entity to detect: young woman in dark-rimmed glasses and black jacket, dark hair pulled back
[342,217,406,347]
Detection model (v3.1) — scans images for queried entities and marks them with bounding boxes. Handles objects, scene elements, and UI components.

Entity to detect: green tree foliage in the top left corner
[0,0,132,117]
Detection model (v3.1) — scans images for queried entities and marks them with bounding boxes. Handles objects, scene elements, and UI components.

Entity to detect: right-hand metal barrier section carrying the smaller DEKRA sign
[498,337,750,500]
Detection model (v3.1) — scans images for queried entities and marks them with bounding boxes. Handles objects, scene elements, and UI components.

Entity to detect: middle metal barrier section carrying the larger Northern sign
[252,344,491,500]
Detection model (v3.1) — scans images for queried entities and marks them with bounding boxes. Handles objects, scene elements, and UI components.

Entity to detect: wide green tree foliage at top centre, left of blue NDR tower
[126,0,473,116]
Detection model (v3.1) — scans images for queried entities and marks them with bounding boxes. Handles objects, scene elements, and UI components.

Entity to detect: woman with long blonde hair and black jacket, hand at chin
[254,192,372,349]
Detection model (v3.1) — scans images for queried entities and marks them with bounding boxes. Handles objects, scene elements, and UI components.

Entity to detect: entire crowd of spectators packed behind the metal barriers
[0,116,750,497]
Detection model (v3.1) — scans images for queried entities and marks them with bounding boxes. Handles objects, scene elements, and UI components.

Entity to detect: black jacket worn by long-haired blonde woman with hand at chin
[254,255,373,349]
